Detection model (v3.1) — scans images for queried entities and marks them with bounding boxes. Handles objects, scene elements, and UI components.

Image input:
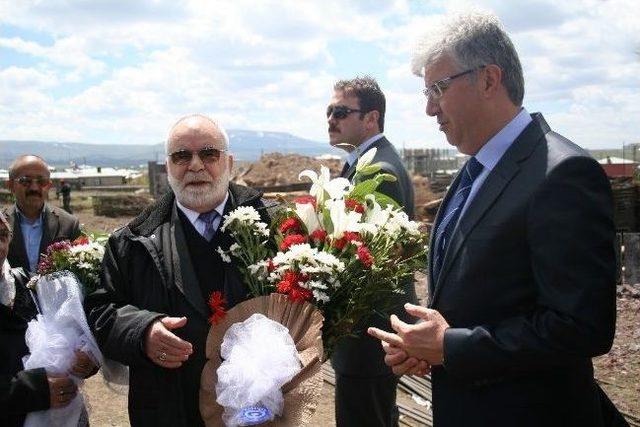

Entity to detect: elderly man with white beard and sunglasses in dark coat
[86,115,271,426]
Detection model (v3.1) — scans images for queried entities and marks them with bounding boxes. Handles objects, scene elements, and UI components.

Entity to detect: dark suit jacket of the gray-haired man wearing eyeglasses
[429,114,616,426]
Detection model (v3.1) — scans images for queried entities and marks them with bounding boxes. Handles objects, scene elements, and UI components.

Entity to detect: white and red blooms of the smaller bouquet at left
[38,235,108,295]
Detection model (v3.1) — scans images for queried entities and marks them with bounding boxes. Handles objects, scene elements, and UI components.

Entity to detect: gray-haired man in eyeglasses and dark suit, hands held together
[369,11,616,427]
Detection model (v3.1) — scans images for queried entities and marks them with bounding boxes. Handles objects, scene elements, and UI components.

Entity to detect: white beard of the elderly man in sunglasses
[167,168,231,212]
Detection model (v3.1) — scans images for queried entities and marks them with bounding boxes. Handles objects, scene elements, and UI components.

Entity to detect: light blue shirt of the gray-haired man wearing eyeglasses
[458,108,533,221]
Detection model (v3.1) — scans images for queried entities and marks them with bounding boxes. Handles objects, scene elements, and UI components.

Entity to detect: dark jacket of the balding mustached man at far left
[7,203,81,271]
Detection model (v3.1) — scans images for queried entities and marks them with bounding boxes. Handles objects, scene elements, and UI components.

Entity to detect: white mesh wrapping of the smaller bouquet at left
[24,271,103,427]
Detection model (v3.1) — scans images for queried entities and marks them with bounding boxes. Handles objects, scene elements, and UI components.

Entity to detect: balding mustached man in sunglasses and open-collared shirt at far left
[7,155,81,272]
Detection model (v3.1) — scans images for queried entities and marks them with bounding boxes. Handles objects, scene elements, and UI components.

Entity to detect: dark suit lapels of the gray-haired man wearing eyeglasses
[428,114,550,307]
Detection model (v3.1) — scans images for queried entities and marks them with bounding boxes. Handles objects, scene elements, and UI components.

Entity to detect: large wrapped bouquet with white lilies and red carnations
[200,149,426,426]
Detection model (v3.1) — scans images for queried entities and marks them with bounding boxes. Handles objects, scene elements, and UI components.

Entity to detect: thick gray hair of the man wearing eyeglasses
[411,13,524,106]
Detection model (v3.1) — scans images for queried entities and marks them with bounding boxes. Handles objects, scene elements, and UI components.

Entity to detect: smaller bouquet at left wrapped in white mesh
[24,237,110,427]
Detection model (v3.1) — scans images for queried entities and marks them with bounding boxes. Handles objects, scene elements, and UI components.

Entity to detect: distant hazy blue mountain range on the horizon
[0,130,343,169]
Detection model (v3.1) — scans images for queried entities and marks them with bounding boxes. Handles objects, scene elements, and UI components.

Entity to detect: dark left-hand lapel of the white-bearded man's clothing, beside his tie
[170,203,209,318]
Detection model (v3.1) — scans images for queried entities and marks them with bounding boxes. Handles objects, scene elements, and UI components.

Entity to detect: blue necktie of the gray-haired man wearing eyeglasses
[433,157,482,283]
